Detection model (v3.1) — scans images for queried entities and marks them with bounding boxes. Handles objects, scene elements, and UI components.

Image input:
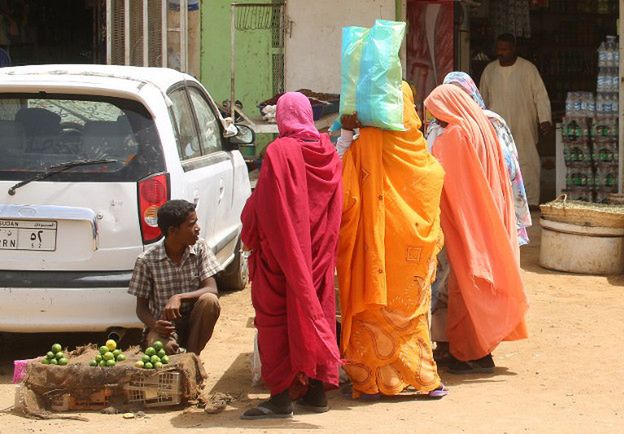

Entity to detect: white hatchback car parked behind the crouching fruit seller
[0,65,254,332]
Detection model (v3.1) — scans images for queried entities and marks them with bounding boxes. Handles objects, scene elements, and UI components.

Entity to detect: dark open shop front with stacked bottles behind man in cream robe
[403,0,622,202]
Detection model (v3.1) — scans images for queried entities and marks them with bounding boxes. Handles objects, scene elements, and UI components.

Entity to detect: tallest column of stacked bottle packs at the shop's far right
[592,36,620,202]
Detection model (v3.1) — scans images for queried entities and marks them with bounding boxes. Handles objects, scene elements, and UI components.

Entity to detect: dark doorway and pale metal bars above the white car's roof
[0,0,201,76]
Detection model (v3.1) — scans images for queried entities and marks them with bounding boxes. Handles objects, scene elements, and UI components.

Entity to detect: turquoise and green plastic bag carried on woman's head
[340,20,405,131]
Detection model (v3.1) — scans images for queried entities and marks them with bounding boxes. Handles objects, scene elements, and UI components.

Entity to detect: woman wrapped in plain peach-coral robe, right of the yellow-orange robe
[425,84,527,373]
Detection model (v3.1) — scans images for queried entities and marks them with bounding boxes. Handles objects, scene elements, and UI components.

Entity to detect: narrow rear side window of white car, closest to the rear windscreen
[169,88,201,161]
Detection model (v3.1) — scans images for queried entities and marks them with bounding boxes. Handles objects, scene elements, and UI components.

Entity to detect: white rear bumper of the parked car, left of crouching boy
[0,284,143,333]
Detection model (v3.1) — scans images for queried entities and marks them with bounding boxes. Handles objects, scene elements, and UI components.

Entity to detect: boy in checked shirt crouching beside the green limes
[128,200,221,355]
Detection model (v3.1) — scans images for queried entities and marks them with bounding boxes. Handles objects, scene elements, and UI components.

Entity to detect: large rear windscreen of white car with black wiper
[0,93,165,182]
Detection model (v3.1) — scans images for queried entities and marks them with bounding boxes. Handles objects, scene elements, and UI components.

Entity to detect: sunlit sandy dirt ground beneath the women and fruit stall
[0,220,624,434]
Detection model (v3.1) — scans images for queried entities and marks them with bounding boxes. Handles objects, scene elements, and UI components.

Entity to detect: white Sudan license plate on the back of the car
[0,219,56,252]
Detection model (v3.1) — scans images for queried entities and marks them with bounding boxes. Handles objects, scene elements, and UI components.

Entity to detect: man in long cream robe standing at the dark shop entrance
[479,34,552,205]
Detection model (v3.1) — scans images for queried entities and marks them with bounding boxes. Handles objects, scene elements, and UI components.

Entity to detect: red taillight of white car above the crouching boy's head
[138,173,169,244]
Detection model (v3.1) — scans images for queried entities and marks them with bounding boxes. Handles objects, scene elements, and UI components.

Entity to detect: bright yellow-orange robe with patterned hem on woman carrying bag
[338,83,446,397]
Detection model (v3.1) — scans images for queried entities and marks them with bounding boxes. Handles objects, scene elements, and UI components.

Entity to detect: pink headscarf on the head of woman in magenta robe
[275,92,320,142]
